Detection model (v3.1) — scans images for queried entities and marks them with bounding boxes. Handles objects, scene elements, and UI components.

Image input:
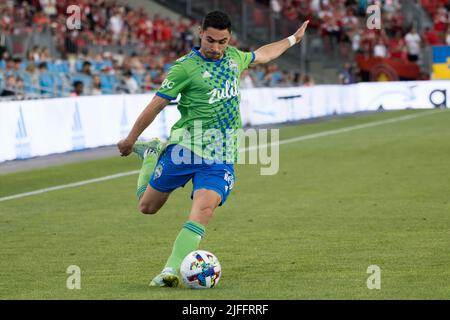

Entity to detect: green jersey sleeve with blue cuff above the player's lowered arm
[156,63,191,100]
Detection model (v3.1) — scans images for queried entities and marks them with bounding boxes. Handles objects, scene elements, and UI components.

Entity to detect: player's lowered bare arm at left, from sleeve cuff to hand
[117,95,170,156]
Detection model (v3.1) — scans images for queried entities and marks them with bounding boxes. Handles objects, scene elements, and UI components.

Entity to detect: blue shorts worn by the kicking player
[149,144,235,205]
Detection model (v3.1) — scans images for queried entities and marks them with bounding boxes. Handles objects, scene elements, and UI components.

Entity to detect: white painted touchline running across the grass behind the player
[0,109,445,202]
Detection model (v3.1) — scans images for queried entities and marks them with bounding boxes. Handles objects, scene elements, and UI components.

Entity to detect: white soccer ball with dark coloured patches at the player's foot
[180,250,222,289]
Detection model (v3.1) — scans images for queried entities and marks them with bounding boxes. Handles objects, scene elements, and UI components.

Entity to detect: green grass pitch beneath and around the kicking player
[0,110,450,299]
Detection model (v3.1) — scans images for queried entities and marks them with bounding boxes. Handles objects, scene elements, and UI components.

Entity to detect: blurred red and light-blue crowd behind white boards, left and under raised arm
[0,0,312,98]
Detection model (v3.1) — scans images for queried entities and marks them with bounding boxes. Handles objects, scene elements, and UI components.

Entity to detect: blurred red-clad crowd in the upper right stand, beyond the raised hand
[260,0,450,62]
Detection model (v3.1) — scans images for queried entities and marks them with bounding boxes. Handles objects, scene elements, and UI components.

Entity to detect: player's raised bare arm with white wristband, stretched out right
[251,20,309,66]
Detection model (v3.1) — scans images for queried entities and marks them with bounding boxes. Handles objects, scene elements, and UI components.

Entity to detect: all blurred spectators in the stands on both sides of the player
[0,0,450,98]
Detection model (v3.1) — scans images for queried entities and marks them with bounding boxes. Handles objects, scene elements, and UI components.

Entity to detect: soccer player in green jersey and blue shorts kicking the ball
[117,11,309,287]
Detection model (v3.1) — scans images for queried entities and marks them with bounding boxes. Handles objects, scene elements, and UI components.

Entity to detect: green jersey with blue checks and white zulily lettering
[156,46,255,162]
